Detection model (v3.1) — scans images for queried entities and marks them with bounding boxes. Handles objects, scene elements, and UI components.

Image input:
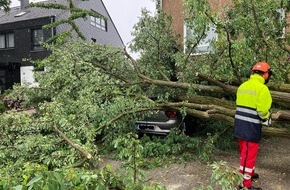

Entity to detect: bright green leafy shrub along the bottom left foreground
[0,163,124,190]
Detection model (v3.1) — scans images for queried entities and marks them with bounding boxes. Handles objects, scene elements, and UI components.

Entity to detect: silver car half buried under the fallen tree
[136,110,193,135]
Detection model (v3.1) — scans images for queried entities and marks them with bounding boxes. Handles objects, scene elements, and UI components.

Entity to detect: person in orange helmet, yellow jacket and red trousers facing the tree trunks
[234,62,272,190]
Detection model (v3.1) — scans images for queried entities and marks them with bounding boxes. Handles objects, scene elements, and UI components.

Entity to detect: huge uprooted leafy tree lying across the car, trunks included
[0,0,290,170]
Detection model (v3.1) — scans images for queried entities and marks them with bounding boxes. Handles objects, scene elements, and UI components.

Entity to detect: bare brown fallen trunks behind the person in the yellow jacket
[160,73,290,138]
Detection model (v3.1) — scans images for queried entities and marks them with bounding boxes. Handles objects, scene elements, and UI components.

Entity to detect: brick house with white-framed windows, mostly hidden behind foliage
[160,0,290,52]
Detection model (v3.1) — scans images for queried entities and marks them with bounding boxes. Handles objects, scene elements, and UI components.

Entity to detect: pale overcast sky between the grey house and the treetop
[11,0,155,51]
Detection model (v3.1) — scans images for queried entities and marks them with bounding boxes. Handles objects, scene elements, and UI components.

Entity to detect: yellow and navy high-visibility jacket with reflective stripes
[234,74,272,142]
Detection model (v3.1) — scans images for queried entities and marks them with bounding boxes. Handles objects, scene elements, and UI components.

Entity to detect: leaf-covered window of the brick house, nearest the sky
[185,26,217,54]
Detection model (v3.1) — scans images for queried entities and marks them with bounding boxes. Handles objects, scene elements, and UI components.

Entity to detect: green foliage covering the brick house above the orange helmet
[184,0,290,82]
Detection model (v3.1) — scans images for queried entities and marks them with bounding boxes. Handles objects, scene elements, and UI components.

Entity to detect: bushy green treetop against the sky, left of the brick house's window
[129,10,179,80]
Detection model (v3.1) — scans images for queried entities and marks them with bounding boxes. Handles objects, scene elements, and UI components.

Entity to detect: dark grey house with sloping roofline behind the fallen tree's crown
[0,0,124,91]
